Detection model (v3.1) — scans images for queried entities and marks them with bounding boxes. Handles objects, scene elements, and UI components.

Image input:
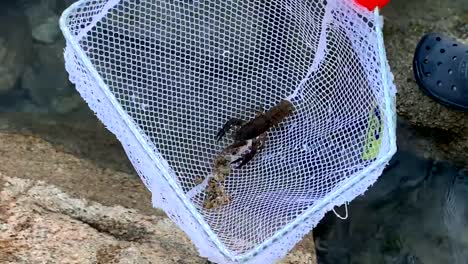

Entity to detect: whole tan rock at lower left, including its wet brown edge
[0,132,316,264]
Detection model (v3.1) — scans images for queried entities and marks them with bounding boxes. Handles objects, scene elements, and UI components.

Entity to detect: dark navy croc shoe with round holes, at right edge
[413,33,468,111]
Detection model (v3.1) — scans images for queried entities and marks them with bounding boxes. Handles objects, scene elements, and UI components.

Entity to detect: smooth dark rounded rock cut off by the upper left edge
[0,8,32,94]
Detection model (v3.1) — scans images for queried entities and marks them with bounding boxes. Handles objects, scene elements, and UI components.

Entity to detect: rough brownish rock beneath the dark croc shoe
[383,0,468,165]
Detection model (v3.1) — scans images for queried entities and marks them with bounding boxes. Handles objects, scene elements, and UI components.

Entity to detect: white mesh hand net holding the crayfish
[60,0,395,263]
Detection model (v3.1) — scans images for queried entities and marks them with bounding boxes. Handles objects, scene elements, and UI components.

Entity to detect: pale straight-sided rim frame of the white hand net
[59,0,397,262]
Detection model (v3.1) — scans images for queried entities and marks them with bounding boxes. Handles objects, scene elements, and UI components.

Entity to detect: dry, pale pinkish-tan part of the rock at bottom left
[0,177,207,263]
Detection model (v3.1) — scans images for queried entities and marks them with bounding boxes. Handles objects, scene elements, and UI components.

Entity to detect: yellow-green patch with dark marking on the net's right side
[362,106,384,160]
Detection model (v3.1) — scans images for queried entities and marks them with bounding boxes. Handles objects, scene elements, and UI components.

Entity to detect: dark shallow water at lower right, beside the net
[314,145,468,264]
